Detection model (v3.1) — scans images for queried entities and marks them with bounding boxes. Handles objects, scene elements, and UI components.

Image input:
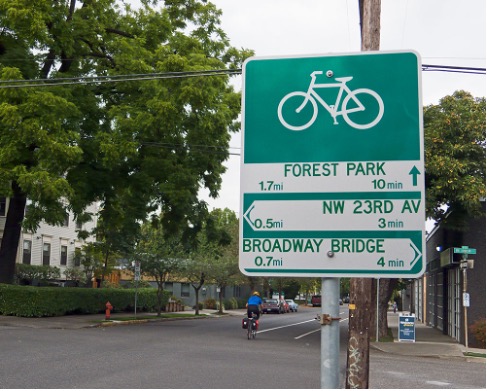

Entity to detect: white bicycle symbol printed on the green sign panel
[277,71,384,130]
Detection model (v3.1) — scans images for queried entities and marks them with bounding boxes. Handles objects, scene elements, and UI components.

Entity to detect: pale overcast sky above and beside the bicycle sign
[201,0,486,213]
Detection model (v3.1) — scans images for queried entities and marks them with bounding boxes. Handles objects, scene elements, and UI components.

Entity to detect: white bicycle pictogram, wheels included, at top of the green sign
[277,71,384,131]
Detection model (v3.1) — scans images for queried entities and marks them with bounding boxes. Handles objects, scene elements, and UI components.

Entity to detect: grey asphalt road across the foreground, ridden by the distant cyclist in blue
[0,307,485,389]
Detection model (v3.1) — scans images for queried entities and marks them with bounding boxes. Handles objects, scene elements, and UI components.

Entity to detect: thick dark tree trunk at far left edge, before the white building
[0,181,27,284]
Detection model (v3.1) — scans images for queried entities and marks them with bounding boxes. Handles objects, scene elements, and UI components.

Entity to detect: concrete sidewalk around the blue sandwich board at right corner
[370,312,485,362]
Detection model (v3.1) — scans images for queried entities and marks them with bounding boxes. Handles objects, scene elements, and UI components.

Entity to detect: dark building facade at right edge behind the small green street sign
[410,202,486,347]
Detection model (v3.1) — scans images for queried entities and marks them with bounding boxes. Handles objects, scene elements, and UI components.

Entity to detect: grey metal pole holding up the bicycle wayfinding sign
[320,278,340,389]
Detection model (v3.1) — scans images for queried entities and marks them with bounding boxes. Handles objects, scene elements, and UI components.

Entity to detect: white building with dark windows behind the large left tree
[0,197,98,275]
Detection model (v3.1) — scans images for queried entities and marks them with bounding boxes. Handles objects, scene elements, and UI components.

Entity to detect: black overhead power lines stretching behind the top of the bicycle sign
[0,64,486,88]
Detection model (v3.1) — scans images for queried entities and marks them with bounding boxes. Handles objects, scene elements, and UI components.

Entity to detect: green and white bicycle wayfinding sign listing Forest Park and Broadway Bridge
[240,52,425,277]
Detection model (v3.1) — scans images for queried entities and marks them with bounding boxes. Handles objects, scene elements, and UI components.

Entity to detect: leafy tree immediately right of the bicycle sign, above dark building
[424,91,486,228]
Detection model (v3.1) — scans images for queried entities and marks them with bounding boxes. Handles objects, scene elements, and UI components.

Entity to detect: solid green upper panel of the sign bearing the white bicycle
[243,52,421,163]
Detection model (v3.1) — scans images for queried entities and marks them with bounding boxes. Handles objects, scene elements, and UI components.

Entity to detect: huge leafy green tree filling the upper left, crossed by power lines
[0,0,250,282]
